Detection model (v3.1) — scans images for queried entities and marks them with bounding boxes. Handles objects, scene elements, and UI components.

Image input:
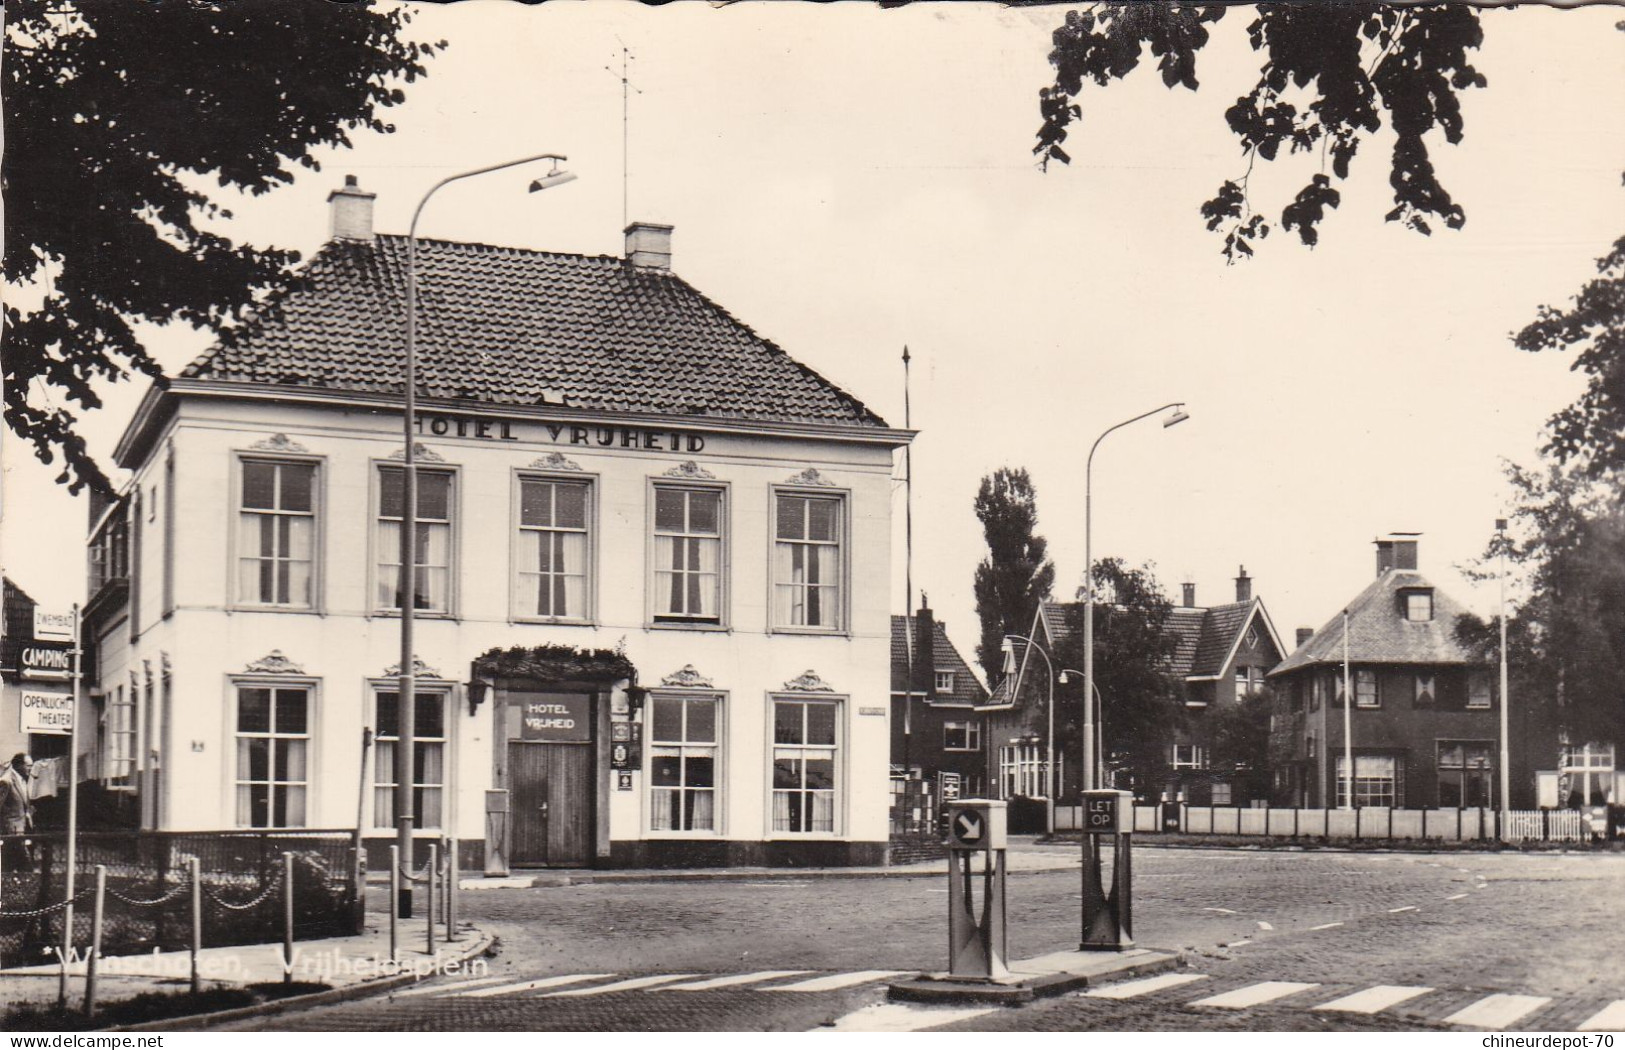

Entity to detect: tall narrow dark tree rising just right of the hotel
[975,466,1055,683]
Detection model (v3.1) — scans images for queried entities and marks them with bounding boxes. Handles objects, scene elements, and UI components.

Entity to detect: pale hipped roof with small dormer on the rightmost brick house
[1269,569,1474,675]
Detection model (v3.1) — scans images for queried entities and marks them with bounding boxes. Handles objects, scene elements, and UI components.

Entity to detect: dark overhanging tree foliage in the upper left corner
[0,0,444,492]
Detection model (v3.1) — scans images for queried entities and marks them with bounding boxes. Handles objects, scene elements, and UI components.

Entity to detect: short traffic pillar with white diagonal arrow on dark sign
[943,798,1009,980]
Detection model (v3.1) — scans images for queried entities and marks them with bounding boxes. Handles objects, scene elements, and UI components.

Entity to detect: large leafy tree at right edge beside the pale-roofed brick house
[1456,465,1625,761]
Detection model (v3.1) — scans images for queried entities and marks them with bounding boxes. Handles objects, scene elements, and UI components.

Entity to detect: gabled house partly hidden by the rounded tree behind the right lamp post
[986,567,1285,815]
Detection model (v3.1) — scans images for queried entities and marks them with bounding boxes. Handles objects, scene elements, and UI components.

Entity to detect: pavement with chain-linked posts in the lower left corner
[0,912,491,1029]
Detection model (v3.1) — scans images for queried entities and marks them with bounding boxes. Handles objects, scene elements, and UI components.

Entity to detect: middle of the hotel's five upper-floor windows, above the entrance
[517,478,592,619]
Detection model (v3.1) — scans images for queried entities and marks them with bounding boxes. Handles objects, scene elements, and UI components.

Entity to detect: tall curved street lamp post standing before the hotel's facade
[395,153,575,918]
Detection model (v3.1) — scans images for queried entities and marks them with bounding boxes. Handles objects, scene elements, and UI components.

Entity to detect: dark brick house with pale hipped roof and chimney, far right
[1269,533,1495,806]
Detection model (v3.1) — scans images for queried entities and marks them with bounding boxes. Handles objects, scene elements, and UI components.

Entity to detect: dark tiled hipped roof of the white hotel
[182,234,886,426]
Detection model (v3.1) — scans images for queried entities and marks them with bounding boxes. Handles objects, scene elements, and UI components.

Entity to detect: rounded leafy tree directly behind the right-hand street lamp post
[1055,558,1185,787]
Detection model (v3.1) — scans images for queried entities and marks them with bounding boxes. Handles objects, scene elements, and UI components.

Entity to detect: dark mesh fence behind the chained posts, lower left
[0,831,366,965]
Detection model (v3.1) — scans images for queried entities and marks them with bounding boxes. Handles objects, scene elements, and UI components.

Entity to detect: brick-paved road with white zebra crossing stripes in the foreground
[237,848,1625,1030]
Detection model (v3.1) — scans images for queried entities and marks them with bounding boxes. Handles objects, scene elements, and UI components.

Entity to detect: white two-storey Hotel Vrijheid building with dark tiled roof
[81,180,910,866]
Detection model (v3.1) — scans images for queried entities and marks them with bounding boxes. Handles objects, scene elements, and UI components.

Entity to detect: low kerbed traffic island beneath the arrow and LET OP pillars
[887,948,1181,1006]
